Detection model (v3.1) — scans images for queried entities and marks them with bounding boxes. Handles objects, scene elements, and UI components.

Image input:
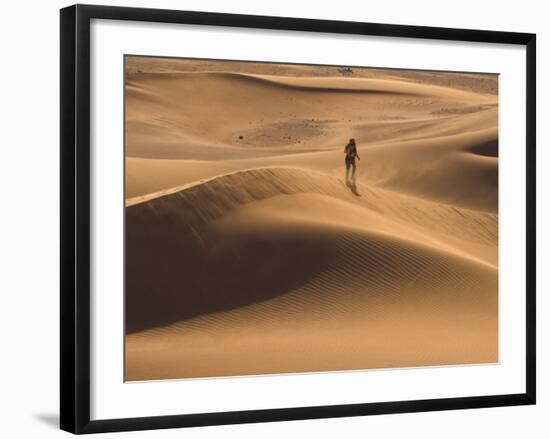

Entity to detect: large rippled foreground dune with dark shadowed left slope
[126,169,497,380]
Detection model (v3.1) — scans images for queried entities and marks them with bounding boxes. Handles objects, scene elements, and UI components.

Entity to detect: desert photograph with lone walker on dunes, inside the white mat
[124,55,499,381]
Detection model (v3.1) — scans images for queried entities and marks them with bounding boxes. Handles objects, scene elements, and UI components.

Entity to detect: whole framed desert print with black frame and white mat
[61,5,536,433]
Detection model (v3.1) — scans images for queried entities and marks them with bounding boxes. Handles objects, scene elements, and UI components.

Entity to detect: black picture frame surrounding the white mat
[60,5,536,434]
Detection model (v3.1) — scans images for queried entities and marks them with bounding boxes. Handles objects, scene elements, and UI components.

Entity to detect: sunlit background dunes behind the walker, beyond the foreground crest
[126,73,498,212]
